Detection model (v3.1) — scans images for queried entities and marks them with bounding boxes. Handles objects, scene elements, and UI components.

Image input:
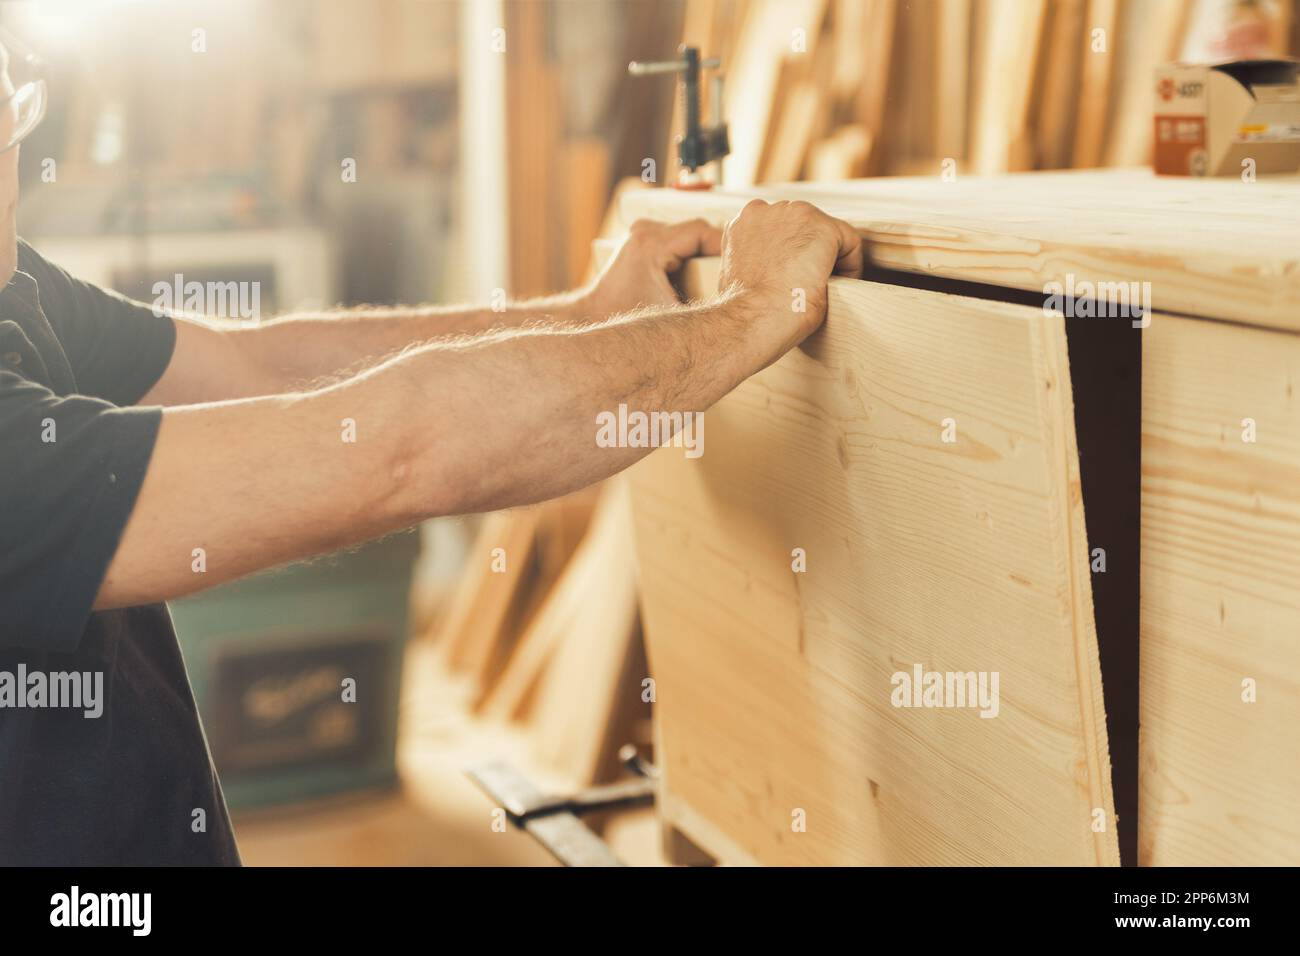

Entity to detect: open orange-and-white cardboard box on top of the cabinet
[1154,60,1300,176]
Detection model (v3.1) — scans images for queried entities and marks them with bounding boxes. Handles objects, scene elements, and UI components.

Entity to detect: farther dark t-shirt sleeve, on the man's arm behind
[18,239,176,405]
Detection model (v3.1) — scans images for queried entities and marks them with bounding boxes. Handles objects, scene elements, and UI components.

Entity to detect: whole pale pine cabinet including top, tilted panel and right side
[621,170,1300,865]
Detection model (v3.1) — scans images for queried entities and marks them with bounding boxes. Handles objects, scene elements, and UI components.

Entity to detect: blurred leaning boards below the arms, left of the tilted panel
[432,481,649,788]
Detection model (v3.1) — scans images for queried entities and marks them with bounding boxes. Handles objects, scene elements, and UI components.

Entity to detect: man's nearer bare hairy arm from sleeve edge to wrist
[98,295,774,607]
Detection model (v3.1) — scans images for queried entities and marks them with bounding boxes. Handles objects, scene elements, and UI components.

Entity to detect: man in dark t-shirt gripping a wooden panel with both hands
[0,35,862,864]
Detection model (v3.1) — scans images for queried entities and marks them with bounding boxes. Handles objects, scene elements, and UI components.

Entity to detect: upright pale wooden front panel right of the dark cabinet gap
[1139,315,1300,866]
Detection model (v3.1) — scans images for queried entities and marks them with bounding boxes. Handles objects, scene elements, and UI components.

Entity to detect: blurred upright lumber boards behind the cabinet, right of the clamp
[672,0,1300,187]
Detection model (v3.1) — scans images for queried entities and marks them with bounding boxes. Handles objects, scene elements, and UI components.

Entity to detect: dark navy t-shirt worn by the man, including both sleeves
[0,242,239,865]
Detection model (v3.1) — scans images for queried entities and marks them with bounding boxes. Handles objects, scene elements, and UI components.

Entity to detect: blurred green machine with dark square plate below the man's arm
[172,529,420,809]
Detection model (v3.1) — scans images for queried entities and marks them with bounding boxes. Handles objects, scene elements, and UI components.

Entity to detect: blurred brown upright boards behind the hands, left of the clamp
[499,0,681,297]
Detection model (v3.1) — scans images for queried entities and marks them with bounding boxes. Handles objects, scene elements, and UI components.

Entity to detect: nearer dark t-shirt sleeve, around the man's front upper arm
[0,371,163,650]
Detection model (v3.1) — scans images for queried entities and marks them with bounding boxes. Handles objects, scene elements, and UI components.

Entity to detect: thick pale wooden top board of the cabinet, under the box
[623,170,1300,330]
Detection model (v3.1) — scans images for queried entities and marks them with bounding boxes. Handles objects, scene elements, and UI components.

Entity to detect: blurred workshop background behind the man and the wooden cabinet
[10,0,1300,865]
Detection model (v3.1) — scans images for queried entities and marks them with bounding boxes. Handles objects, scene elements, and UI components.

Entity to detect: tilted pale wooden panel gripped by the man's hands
[631,260,1118,865]
